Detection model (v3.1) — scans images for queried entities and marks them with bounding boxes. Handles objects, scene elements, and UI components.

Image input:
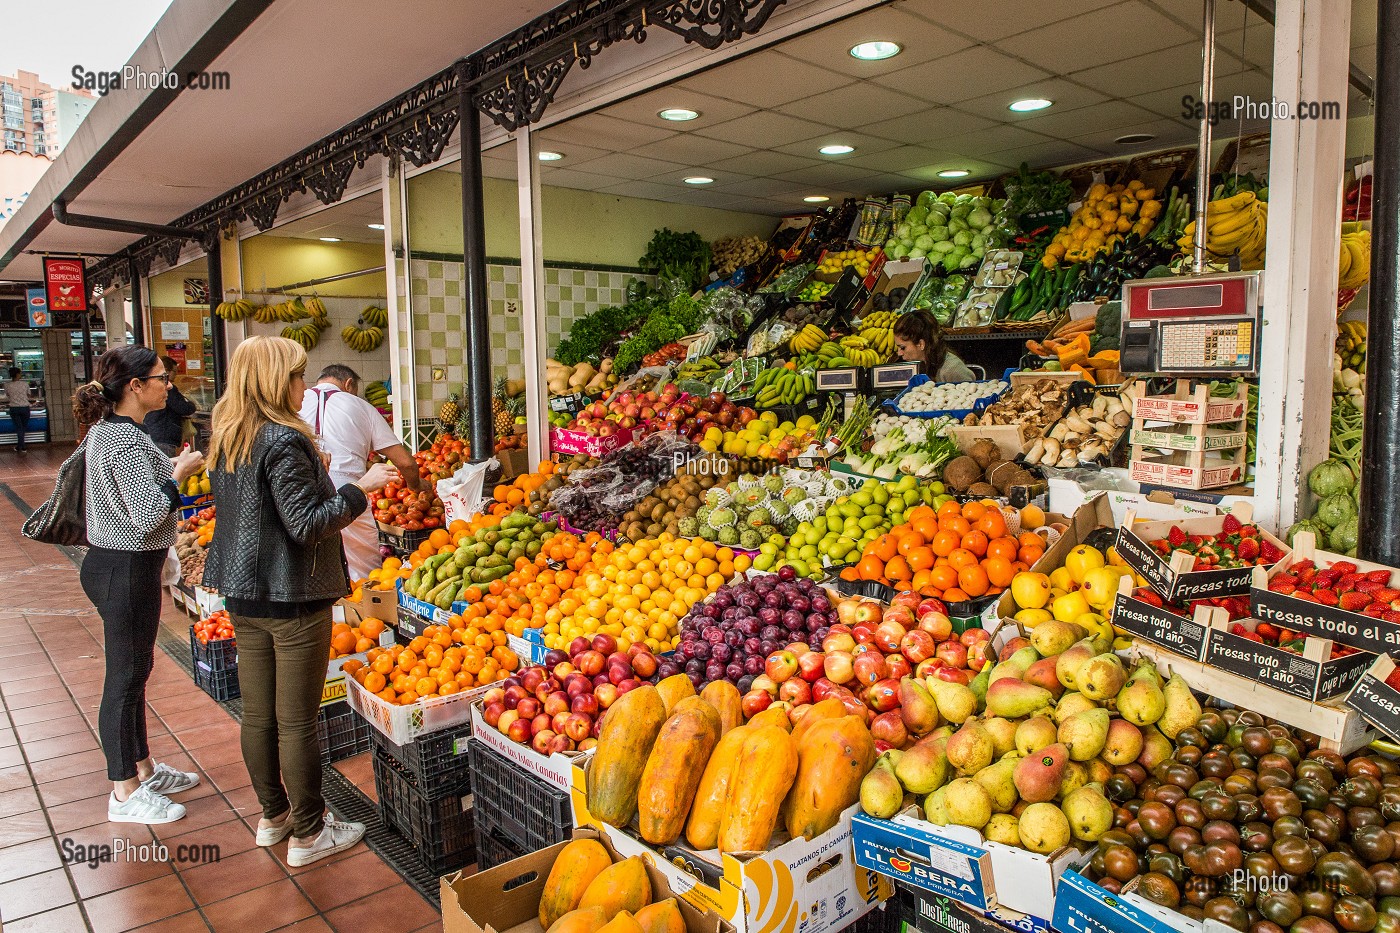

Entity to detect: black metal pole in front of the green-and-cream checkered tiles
[458,88,496,464]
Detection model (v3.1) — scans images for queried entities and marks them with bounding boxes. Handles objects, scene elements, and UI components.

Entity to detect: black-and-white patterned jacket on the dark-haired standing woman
[84,415,181,551]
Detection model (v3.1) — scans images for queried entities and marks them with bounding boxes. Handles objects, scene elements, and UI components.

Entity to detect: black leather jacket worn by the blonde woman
[204,424,370,602]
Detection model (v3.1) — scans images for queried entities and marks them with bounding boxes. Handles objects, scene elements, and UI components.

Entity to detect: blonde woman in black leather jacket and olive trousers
[204,336,398,867]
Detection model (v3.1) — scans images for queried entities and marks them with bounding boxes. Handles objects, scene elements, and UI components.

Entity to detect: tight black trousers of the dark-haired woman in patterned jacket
[78,548,165,780]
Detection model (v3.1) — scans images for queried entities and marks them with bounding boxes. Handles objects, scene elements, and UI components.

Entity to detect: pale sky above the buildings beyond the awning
[0,0,171,87]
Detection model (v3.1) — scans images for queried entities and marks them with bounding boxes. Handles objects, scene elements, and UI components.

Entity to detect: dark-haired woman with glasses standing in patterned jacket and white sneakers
[73,346,204,824]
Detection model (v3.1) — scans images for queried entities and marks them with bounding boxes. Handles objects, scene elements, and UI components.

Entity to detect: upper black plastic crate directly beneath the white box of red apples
[472,742,574,852]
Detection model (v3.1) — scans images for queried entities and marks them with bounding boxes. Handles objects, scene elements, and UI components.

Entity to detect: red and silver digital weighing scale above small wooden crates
[1119,272,1263,375]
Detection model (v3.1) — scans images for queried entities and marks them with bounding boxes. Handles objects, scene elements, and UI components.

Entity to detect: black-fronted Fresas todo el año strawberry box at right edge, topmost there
[1249,532,1400,654]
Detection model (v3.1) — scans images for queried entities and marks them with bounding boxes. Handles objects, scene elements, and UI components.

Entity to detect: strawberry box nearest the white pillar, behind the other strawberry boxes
[1114,504,1289,602]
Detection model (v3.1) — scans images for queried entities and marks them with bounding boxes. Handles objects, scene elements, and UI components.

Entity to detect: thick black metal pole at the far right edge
[1357,3,1400,554]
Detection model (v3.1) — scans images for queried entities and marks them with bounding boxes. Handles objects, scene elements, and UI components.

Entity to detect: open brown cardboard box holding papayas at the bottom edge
[438,829,734,933]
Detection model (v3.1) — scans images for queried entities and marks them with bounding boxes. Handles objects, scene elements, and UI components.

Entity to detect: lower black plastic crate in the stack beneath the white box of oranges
[374,751,476,874]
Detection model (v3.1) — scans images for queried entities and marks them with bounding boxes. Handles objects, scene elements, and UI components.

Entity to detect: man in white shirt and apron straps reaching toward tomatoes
[301,364,424,580]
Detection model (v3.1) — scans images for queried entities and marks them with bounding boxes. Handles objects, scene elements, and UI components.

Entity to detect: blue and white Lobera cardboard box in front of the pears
[851,807,1093,916]
